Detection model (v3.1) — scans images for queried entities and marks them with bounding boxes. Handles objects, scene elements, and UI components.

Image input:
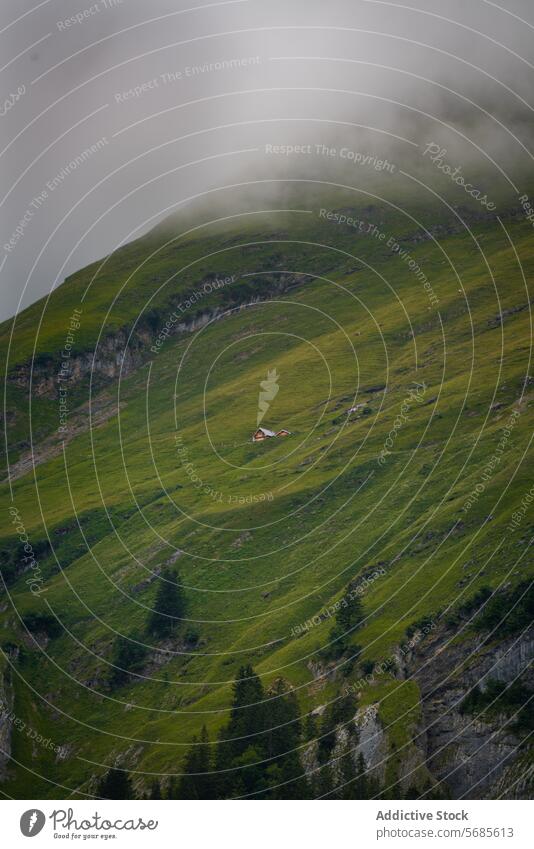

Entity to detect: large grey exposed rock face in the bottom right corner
[408,629,534,799]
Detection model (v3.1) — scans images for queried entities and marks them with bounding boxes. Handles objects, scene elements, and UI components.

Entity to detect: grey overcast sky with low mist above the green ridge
[0,0,534,318]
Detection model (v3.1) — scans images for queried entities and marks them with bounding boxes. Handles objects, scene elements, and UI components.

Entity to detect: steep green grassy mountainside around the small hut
[0,190,534,798]
